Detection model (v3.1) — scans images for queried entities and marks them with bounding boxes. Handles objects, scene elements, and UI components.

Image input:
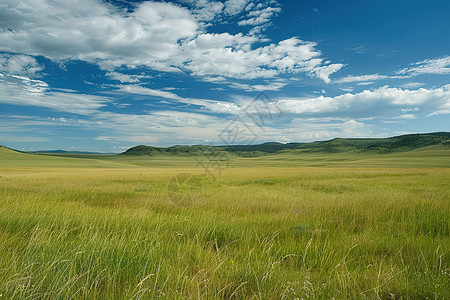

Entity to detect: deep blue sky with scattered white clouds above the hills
[0,0,450,153]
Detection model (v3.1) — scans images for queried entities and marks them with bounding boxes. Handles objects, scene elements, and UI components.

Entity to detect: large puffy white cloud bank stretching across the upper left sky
[0,0,342,83]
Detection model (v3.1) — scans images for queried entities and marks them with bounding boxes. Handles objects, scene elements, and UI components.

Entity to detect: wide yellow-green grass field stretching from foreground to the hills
[0,149,450,299]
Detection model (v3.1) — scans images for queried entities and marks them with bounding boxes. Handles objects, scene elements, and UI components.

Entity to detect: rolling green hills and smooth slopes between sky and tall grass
[0,132,450,168]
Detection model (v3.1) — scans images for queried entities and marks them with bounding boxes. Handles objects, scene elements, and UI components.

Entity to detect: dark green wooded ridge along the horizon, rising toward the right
[122,132,450,156]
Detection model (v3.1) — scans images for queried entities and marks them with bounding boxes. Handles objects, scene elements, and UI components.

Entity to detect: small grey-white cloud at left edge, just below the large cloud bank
[0,53,44,77]
